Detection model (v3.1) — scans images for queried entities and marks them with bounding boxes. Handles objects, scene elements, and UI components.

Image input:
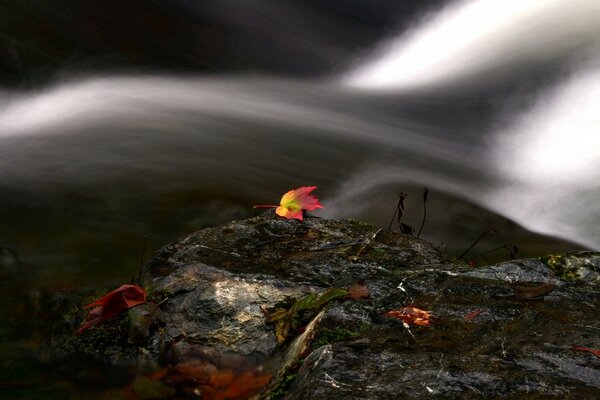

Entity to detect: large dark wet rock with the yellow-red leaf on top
[38,211,600,399]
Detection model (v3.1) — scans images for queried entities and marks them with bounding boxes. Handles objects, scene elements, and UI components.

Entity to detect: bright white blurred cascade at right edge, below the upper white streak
[485,66,600,249]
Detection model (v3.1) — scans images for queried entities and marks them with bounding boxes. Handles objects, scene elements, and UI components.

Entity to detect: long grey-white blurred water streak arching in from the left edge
[0,76,467,194]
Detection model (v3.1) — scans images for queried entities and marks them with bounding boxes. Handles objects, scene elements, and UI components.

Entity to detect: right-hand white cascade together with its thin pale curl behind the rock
[325,61,600,249]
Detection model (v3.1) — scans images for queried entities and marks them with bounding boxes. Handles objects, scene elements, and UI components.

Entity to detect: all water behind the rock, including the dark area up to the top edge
[0,0,600,397]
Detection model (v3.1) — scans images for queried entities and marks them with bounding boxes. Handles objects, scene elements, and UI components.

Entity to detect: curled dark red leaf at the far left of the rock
[75,285,146,336]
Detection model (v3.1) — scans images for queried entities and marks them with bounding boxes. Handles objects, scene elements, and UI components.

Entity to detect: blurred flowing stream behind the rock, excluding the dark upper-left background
[0,0,600,283]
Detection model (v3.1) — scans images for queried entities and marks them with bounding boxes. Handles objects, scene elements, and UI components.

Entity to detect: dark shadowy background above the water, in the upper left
[0,0,443,88]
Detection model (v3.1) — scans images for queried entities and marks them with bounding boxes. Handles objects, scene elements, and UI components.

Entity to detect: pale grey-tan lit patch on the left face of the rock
[151,263,310,359]
